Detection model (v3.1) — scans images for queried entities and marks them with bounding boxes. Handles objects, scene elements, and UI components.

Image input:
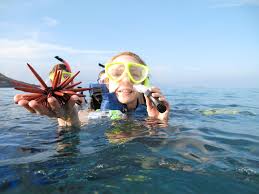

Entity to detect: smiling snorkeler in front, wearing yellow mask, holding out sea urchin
[14,52,170,126]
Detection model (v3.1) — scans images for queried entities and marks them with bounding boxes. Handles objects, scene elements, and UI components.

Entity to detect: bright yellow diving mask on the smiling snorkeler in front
[105,62,149,85]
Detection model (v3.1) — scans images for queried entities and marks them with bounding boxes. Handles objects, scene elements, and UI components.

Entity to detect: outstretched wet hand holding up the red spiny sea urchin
[14,94,80,126]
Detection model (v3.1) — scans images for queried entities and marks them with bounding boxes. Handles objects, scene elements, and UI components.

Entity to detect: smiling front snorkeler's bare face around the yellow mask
[109,55,139,104]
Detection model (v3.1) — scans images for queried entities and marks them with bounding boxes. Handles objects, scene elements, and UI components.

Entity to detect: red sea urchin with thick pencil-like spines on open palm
[13,63,91,107]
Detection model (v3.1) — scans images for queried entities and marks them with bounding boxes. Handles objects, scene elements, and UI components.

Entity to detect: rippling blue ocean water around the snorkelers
[0,88,259,194]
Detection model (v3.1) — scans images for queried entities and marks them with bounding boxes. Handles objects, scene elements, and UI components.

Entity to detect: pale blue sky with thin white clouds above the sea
[0,0,259,88]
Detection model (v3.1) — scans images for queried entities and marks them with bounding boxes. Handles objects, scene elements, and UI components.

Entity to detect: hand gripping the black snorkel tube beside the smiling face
[145,87,170,121]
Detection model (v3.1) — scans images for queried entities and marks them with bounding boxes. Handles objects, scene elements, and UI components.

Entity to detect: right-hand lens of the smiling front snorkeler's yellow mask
[129,64,148,82]
